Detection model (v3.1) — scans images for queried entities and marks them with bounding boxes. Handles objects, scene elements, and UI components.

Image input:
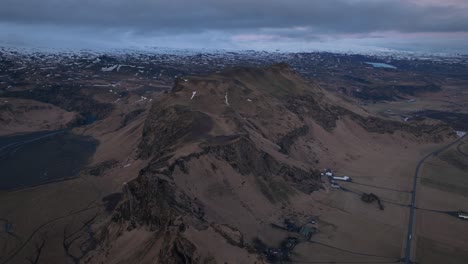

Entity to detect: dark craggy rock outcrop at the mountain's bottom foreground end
[100,172,210,264]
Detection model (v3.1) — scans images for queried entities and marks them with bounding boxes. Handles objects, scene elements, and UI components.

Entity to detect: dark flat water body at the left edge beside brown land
[0,130,98,190]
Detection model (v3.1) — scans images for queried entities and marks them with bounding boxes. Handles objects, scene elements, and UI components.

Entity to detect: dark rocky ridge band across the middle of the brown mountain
[144,136,321,202]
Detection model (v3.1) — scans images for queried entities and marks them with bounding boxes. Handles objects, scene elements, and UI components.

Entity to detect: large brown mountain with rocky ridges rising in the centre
[91,64,452,263]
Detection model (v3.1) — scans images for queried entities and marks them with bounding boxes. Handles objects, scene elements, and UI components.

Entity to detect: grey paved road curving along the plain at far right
[404,135,466,264]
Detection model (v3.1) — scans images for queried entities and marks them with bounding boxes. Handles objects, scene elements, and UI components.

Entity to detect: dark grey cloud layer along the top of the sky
[0,0,468,34]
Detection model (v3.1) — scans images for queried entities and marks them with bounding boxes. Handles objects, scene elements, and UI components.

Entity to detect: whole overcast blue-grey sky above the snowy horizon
[0,0,468,53]
